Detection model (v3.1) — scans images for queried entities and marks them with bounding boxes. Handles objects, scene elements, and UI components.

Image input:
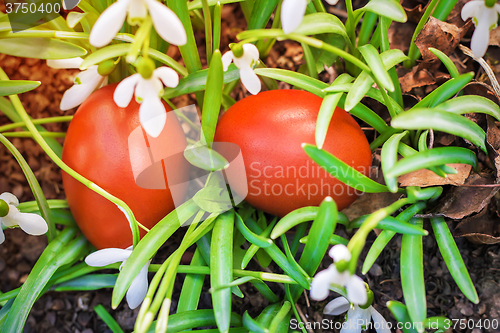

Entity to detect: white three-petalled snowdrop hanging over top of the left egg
[113,66,179,138]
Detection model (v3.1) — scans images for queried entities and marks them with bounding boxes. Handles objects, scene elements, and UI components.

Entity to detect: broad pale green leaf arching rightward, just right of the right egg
[391,108,487,153]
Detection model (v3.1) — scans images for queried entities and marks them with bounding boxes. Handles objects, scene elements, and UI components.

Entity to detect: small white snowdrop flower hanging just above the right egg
[222,44,261,95]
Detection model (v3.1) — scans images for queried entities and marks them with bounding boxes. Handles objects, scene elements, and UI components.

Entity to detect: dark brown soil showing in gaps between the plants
[0,0,500,333]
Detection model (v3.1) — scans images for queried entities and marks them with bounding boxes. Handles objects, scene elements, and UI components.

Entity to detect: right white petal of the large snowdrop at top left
[144,0,187,45]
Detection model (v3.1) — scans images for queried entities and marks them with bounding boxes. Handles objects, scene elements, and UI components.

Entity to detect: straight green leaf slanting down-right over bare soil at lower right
[431,217,479,304]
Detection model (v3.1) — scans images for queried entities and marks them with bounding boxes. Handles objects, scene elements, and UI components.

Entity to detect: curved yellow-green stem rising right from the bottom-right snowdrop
[347,198,410,274]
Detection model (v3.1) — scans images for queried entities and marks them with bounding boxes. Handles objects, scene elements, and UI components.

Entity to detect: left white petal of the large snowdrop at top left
[89,0,130,47]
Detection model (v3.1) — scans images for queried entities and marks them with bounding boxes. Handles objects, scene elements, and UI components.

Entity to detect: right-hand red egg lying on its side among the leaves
[215,90,372,216]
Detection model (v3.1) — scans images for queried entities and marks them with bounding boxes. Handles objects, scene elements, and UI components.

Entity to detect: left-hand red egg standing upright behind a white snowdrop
[62,84,189,249]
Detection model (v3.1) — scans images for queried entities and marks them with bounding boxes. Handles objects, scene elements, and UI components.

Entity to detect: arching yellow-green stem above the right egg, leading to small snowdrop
[236,29,371,73]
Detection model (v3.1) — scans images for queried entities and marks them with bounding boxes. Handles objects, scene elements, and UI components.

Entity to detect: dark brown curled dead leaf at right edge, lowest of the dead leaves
[453,202,500,244]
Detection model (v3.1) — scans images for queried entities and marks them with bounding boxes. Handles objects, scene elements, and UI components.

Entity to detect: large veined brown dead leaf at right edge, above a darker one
[431,173,499,220]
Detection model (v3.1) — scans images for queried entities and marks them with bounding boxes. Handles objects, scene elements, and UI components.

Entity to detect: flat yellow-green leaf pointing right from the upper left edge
[0,38,87,59]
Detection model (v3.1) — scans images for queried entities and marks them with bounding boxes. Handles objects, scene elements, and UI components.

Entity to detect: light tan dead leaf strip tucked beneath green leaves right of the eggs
[398,164,472,187]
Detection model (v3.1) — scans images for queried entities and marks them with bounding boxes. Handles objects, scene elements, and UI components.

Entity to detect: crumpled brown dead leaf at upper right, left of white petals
[415,16,472,61]
